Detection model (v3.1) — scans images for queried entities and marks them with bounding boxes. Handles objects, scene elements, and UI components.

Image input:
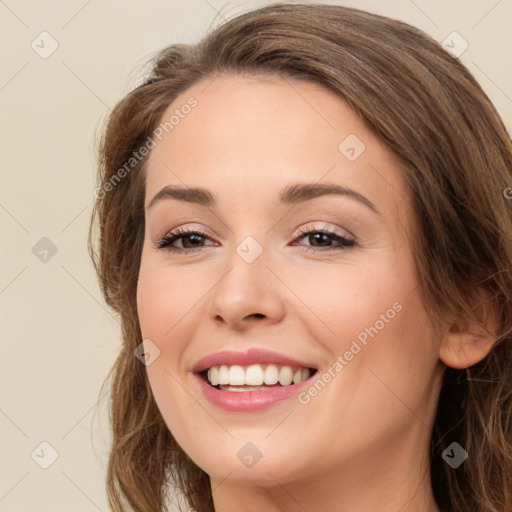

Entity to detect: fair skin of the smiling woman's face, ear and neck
[137,75,490,512]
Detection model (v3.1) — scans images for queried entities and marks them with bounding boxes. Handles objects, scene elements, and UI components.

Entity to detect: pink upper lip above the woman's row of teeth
[192,348,317,373]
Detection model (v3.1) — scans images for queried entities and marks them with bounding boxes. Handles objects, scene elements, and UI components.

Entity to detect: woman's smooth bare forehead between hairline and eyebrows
[142,71,406,218]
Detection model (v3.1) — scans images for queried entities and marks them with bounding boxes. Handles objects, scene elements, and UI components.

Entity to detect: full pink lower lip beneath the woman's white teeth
[194,374,311,412]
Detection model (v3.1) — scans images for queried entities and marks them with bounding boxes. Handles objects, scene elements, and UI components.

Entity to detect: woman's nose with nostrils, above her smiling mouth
[208,251,285,331]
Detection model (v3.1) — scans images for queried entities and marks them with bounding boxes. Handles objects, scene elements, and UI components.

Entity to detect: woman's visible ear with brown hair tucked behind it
[439,292,498,369]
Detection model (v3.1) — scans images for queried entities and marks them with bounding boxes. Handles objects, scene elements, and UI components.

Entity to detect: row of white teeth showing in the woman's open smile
[207,364,310,391]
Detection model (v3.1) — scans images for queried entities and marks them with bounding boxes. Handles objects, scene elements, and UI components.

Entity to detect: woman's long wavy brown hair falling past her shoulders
[89,4,512,512]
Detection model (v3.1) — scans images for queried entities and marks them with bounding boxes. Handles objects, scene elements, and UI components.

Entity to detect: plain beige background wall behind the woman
[0,0,512,512]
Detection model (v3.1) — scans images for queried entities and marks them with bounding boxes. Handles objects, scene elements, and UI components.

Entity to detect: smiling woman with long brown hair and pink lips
[90,4,512,512]
